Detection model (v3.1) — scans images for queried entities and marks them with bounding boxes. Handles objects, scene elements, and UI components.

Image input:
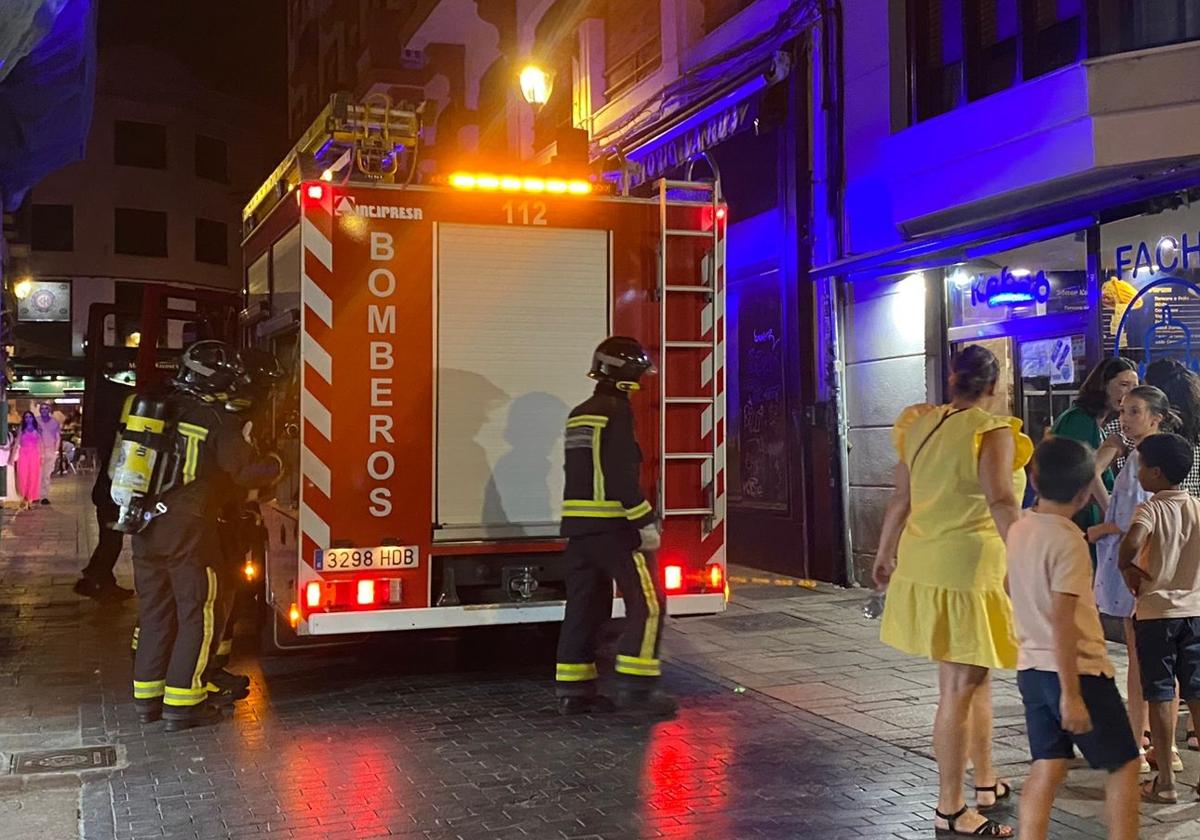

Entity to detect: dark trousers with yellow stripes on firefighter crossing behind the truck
[556,532,666,697]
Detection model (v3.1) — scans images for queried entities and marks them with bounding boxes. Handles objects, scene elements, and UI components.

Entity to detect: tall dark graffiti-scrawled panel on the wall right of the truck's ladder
[737,275,788,511]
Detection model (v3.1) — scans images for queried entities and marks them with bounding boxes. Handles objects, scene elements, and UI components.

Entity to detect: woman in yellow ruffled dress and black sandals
[875,344,1033,838]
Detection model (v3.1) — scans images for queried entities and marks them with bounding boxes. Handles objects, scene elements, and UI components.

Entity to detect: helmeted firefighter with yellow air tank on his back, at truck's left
[133,341,281,732]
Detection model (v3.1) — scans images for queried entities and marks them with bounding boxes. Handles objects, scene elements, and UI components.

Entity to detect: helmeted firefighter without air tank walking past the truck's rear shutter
[556,336,676,716]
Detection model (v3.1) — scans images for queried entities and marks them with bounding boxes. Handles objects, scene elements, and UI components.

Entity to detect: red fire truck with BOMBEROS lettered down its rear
[242,95,726,636]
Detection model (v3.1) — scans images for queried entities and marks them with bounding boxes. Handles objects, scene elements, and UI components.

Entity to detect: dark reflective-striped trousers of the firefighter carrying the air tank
[133,520,220,710]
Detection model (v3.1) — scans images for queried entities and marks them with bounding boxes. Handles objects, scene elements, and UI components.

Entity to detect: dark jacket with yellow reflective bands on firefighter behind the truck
[562,383,655,536]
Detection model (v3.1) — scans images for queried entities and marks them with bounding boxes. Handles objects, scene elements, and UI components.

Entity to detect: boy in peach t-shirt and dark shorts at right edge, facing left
[1120,434,1200,803]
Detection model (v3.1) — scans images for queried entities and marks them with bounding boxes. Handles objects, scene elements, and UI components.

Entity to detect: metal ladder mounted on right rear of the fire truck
[659,179,725,535]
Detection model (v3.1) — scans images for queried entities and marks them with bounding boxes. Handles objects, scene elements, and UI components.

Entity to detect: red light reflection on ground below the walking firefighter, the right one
[641,709,734,838]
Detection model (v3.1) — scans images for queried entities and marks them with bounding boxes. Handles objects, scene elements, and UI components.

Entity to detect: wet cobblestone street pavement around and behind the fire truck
[0,479,1200,840]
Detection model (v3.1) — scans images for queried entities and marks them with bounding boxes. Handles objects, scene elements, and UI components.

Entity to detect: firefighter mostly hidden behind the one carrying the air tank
[205,348,283,706]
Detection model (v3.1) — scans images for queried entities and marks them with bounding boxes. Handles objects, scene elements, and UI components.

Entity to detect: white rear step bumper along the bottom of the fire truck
[304,593,725,636]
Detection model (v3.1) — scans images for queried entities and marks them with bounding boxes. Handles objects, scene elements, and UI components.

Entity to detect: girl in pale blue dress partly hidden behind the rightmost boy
[1087,385,1183,773]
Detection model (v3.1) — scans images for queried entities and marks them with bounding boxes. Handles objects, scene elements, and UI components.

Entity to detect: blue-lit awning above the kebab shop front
[809,154,1200,280]
